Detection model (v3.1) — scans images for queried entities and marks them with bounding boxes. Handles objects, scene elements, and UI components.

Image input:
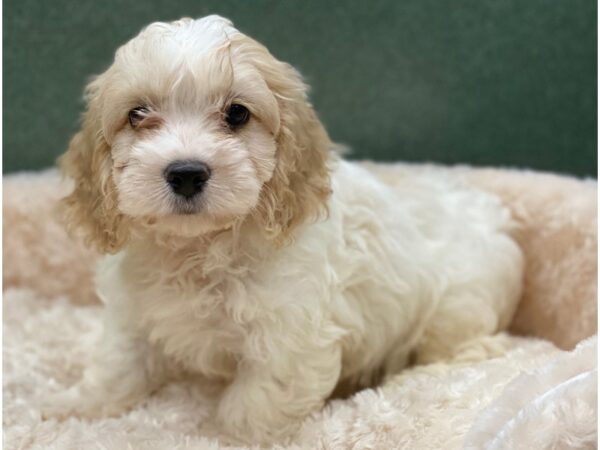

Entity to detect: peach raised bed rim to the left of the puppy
[2,169,98,304]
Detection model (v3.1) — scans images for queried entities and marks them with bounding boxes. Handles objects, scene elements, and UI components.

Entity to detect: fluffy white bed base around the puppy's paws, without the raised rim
[4,289,596,450]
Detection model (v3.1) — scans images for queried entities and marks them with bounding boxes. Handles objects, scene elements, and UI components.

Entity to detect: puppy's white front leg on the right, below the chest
[218,344,341,444]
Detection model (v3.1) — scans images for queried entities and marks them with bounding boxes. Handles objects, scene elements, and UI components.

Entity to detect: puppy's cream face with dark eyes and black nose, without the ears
[102,19,280,233]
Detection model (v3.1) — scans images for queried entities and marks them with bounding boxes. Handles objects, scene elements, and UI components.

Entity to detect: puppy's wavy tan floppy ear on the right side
[248,49,333,242]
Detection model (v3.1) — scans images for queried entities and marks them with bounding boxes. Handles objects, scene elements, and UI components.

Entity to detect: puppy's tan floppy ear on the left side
[59,78,129,253]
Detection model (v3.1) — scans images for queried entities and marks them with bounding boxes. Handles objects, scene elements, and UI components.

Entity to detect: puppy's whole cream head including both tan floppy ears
[60,16,331,253]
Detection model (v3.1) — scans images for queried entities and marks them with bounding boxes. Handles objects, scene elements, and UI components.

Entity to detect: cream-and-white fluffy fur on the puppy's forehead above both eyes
[101,16,280,144]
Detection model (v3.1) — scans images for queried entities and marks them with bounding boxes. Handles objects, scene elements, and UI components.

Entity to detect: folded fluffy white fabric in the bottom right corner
[465,336,598,450]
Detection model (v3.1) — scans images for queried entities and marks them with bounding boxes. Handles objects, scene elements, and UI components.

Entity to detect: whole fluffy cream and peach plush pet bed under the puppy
[3,164,597,450]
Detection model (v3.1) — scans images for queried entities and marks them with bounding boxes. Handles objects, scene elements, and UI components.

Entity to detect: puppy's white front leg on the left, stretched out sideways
[42,309,166,419]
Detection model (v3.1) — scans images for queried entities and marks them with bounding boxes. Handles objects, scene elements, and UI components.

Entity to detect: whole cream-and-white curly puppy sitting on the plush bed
[46,16,522,443]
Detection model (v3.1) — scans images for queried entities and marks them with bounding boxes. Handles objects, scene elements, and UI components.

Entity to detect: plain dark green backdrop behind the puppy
[3,0,597,175]
